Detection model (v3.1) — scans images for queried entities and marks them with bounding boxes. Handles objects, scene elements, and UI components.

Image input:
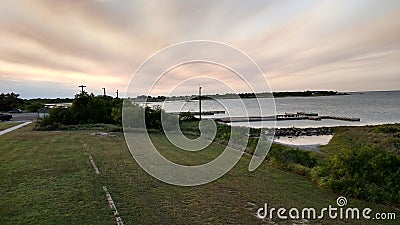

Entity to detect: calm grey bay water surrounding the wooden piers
[148,91,400,127]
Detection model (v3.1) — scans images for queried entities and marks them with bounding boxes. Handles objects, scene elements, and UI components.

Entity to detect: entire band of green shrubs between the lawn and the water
[34,97,400,207]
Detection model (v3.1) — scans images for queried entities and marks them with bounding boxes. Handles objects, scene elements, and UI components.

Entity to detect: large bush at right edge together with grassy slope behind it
[312,124,400,205]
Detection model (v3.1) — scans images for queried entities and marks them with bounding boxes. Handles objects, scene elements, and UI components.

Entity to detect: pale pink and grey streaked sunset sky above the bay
[0,0,400,98]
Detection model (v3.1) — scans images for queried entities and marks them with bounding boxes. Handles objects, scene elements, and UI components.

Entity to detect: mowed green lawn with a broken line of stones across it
[0,125,399,224]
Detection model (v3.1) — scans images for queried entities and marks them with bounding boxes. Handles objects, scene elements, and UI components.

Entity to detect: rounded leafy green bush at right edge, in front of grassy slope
[311,146,400,203]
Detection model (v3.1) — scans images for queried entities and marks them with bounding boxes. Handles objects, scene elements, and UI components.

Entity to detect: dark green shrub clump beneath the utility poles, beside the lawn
[35,92,180,131]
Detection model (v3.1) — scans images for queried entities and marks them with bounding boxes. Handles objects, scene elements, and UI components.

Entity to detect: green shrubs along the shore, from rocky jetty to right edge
[181,121,400,204]
